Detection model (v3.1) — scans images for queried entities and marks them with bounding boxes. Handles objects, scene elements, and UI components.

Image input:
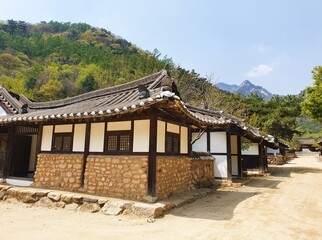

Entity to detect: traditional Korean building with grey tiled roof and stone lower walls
[0,70,280,201]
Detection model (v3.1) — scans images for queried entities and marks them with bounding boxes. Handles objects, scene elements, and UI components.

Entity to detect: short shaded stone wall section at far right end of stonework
[191,159,215,188]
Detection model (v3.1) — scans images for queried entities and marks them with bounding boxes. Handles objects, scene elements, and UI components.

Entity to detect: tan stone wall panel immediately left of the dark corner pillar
[84,155,148,200]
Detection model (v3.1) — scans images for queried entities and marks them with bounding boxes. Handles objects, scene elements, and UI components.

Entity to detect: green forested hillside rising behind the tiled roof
[0,20,316,143]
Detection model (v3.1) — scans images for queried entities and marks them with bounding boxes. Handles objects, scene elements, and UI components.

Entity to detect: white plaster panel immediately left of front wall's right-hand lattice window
[89,123,105,152]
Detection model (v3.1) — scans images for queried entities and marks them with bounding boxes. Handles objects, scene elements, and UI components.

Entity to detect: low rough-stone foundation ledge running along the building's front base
[0,184,171,218]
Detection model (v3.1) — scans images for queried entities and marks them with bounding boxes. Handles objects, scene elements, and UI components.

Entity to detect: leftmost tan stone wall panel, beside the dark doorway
[34,153,84,191]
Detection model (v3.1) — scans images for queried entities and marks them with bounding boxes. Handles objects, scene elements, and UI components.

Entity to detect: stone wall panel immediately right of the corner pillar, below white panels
[156,156,193,199]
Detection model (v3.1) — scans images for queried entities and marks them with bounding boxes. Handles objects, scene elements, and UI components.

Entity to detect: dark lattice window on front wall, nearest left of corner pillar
[105,131,132,153]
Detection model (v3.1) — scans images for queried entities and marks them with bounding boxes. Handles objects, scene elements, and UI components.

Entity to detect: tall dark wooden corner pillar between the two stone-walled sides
[148,111,158,198]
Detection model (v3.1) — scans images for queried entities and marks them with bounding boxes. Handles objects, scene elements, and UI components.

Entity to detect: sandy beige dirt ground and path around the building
[0,156,322,240]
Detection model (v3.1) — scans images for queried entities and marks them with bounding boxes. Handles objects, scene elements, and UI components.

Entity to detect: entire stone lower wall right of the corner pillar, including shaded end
[156,156,214,199]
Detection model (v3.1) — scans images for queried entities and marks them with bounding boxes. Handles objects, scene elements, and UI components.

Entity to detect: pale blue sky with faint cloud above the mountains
[0,0,322,95]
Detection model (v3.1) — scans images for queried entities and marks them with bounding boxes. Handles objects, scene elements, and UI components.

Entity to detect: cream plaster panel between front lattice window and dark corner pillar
[133,120,150,152]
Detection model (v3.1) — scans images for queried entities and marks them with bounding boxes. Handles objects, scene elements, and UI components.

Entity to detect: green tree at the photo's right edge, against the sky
[302,66,322,122]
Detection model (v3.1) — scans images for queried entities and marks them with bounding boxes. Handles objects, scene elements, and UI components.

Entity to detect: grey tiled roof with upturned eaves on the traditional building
[0,70,274,148]
